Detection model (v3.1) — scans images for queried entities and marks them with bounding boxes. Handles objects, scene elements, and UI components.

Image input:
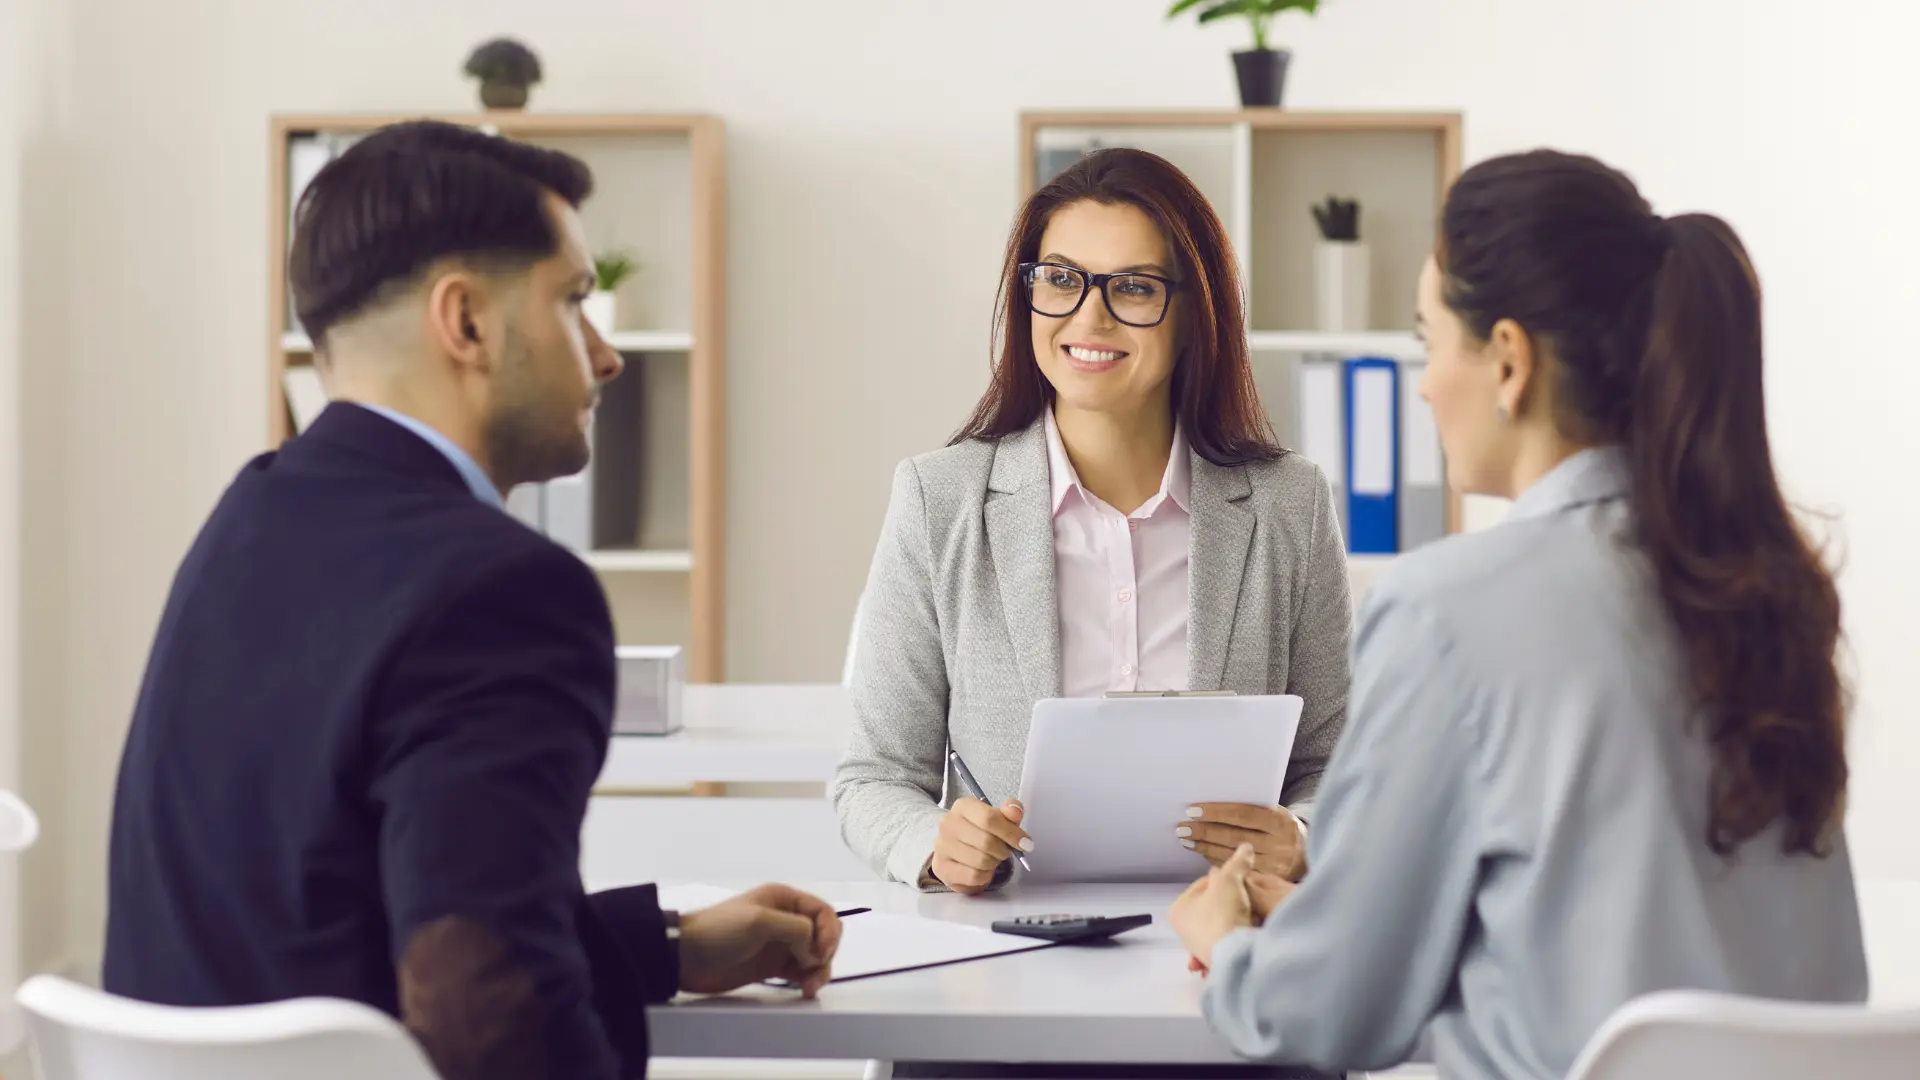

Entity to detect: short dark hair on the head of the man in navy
[288,121,593,348]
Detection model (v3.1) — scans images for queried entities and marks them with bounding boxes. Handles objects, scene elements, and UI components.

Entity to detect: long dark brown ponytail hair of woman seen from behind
[1436,150,1847,855]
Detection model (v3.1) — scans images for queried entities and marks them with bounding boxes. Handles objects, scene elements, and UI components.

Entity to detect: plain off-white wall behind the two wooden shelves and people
[15,0,1920,972]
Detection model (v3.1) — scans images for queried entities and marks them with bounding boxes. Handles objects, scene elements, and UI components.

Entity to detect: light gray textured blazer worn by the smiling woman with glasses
[829,423,1352,884]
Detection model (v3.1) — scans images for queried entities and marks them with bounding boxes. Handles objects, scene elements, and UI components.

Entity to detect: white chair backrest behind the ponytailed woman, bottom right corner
[1567,990,1920,1080]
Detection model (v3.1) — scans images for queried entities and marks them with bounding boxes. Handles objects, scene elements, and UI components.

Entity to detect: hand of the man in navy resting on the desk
[680,886,841,997]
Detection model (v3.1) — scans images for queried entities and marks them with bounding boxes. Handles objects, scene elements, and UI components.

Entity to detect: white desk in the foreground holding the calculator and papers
[647,882,1240,1065]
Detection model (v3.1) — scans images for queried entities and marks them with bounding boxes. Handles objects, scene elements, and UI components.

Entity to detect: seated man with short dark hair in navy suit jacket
[106,123,839,1080]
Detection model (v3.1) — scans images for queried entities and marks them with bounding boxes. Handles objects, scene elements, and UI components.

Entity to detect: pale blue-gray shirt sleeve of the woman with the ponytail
[1200,586,1486,1070]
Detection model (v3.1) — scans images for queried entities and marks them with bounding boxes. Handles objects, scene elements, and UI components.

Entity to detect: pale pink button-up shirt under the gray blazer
[1046,409,1192,698]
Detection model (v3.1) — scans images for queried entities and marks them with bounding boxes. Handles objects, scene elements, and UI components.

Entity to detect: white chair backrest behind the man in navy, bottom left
[19,974,434,1080]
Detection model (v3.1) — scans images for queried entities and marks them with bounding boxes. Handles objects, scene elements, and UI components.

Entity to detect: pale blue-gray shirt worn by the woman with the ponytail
[1202,450,1866,1080]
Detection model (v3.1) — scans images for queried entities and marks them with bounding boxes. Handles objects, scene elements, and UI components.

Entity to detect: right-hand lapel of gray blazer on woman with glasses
[1187,454,1254,690]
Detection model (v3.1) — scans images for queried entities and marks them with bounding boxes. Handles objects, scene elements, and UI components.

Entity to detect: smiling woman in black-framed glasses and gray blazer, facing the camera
[831,148,1352,894]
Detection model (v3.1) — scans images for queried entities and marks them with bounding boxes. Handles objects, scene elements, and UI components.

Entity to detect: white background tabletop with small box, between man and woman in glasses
[599,682,852,790]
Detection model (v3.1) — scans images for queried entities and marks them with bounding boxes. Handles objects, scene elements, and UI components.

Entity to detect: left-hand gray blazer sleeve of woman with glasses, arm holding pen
[828,461,947,884]
